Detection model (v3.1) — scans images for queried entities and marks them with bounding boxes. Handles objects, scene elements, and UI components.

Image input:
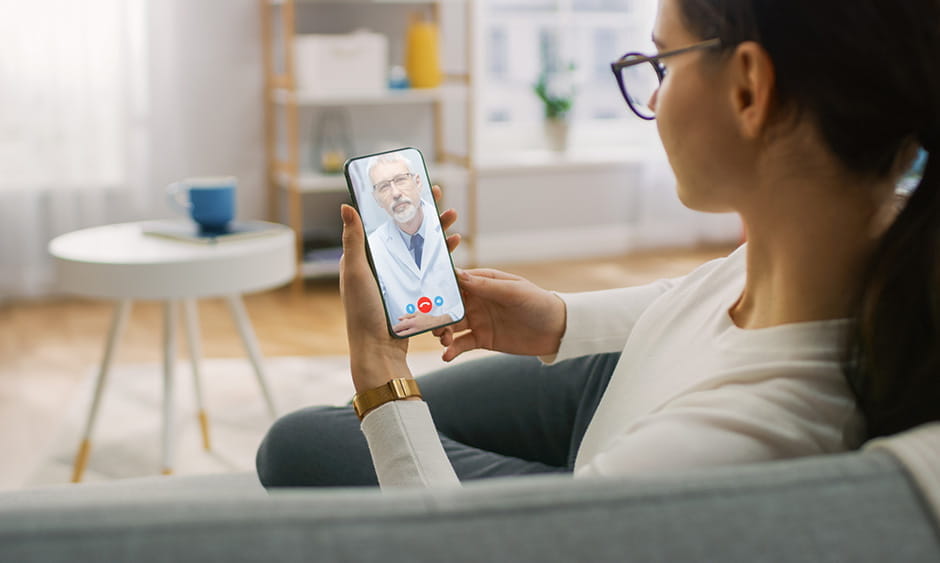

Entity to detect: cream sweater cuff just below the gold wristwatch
[362,401,460,488]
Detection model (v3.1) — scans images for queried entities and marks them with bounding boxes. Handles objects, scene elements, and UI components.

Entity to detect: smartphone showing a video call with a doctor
[343,147,464,338]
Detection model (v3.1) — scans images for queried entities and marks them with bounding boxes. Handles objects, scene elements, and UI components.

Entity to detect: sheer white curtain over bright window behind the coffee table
[0,0,267,301]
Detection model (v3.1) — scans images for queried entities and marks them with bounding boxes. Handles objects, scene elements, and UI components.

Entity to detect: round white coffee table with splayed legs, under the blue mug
[49,222,296,482]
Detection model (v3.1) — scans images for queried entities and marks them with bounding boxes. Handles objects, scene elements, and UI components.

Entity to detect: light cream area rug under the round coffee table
[25,351,487,486]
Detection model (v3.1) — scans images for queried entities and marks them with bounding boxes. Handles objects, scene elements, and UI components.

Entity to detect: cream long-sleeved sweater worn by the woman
[362,247,861,487]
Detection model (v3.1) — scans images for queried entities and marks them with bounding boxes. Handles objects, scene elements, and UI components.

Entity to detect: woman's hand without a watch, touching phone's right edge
[434,270,567,361]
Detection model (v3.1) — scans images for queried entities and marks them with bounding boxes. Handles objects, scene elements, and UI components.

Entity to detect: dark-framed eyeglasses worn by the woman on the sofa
[610,38,721,120]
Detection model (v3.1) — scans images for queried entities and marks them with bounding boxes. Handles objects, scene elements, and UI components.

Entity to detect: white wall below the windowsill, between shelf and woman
[477,150,741,263]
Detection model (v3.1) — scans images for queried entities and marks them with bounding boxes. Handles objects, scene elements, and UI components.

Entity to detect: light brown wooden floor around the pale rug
[0,247,731,489]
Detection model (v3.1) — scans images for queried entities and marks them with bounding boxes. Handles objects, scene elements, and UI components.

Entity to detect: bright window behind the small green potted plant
[476,0,655,151]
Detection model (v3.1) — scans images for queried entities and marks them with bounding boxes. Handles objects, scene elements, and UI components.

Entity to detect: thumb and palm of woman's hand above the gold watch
[339,205,411,393]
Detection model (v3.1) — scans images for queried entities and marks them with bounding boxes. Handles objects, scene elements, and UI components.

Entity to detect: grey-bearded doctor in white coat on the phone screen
[367,153,463,336]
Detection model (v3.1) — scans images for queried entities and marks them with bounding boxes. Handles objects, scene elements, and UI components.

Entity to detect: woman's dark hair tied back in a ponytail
[678,0,940,438]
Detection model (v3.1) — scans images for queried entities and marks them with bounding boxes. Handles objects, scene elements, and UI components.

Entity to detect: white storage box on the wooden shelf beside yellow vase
[294,31,388,96]
